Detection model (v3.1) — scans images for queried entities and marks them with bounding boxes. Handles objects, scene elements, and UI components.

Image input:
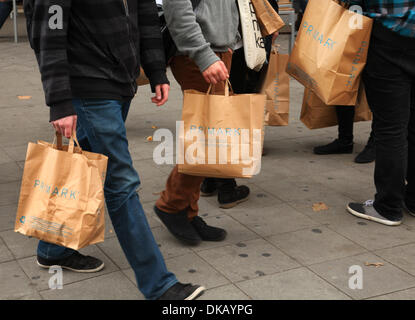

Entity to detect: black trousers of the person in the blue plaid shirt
[363,23,415,218]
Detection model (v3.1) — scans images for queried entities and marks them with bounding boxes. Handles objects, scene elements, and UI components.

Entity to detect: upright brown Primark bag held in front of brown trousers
[178,82,266,178]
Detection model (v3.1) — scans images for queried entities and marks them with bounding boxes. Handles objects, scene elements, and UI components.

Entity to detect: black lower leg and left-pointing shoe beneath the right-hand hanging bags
[313,106,355,155]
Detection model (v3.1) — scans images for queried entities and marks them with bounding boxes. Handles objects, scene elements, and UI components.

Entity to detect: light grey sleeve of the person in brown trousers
[163,0,220,72]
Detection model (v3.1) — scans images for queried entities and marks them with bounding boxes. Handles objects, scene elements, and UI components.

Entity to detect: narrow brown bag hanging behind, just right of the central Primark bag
[260,48,290,126]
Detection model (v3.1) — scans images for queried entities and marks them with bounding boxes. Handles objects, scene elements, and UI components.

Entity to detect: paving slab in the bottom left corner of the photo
[0,261,36,300]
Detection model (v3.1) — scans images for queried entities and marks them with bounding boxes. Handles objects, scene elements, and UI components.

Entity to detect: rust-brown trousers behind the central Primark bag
[156,52,232,219]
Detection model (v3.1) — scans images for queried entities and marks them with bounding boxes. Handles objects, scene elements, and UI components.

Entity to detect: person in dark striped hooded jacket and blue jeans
[24,0,204,300]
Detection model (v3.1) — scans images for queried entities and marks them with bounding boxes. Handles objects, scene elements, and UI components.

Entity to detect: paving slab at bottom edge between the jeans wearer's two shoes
[39,271,144,300]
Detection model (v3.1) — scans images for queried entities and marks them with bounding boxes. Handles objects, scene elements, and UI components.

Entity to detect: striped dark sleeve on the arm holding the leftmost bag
[24,0,76,121]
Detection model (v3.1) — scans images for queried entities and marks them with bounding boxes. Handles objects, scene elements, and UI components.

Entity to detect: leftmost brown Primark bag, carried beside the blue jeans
[15,132,108,250]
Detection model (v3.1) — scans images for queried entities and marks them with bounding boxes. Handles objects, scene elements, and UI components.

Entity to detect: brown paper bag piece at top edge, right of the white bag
[251,0,285,37]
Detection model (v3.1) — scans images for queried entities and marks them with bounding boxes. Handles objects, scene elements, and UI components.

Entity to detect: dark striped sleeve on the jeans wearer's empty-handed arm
[137,0,169,92]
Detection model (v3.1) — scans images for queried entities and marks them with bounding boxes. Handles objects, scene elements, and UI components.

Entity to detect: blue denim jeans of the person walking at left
[37,99,177,299]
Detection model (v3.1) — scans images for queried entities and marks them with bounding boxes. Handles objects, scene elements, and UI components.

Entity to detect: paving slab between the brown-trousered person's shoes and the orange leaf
[229,203,319,237]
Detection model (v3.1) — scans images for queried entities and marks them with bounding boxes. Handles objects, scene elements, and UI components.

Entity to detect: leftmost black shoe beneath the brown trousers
[154,206,202,245]
